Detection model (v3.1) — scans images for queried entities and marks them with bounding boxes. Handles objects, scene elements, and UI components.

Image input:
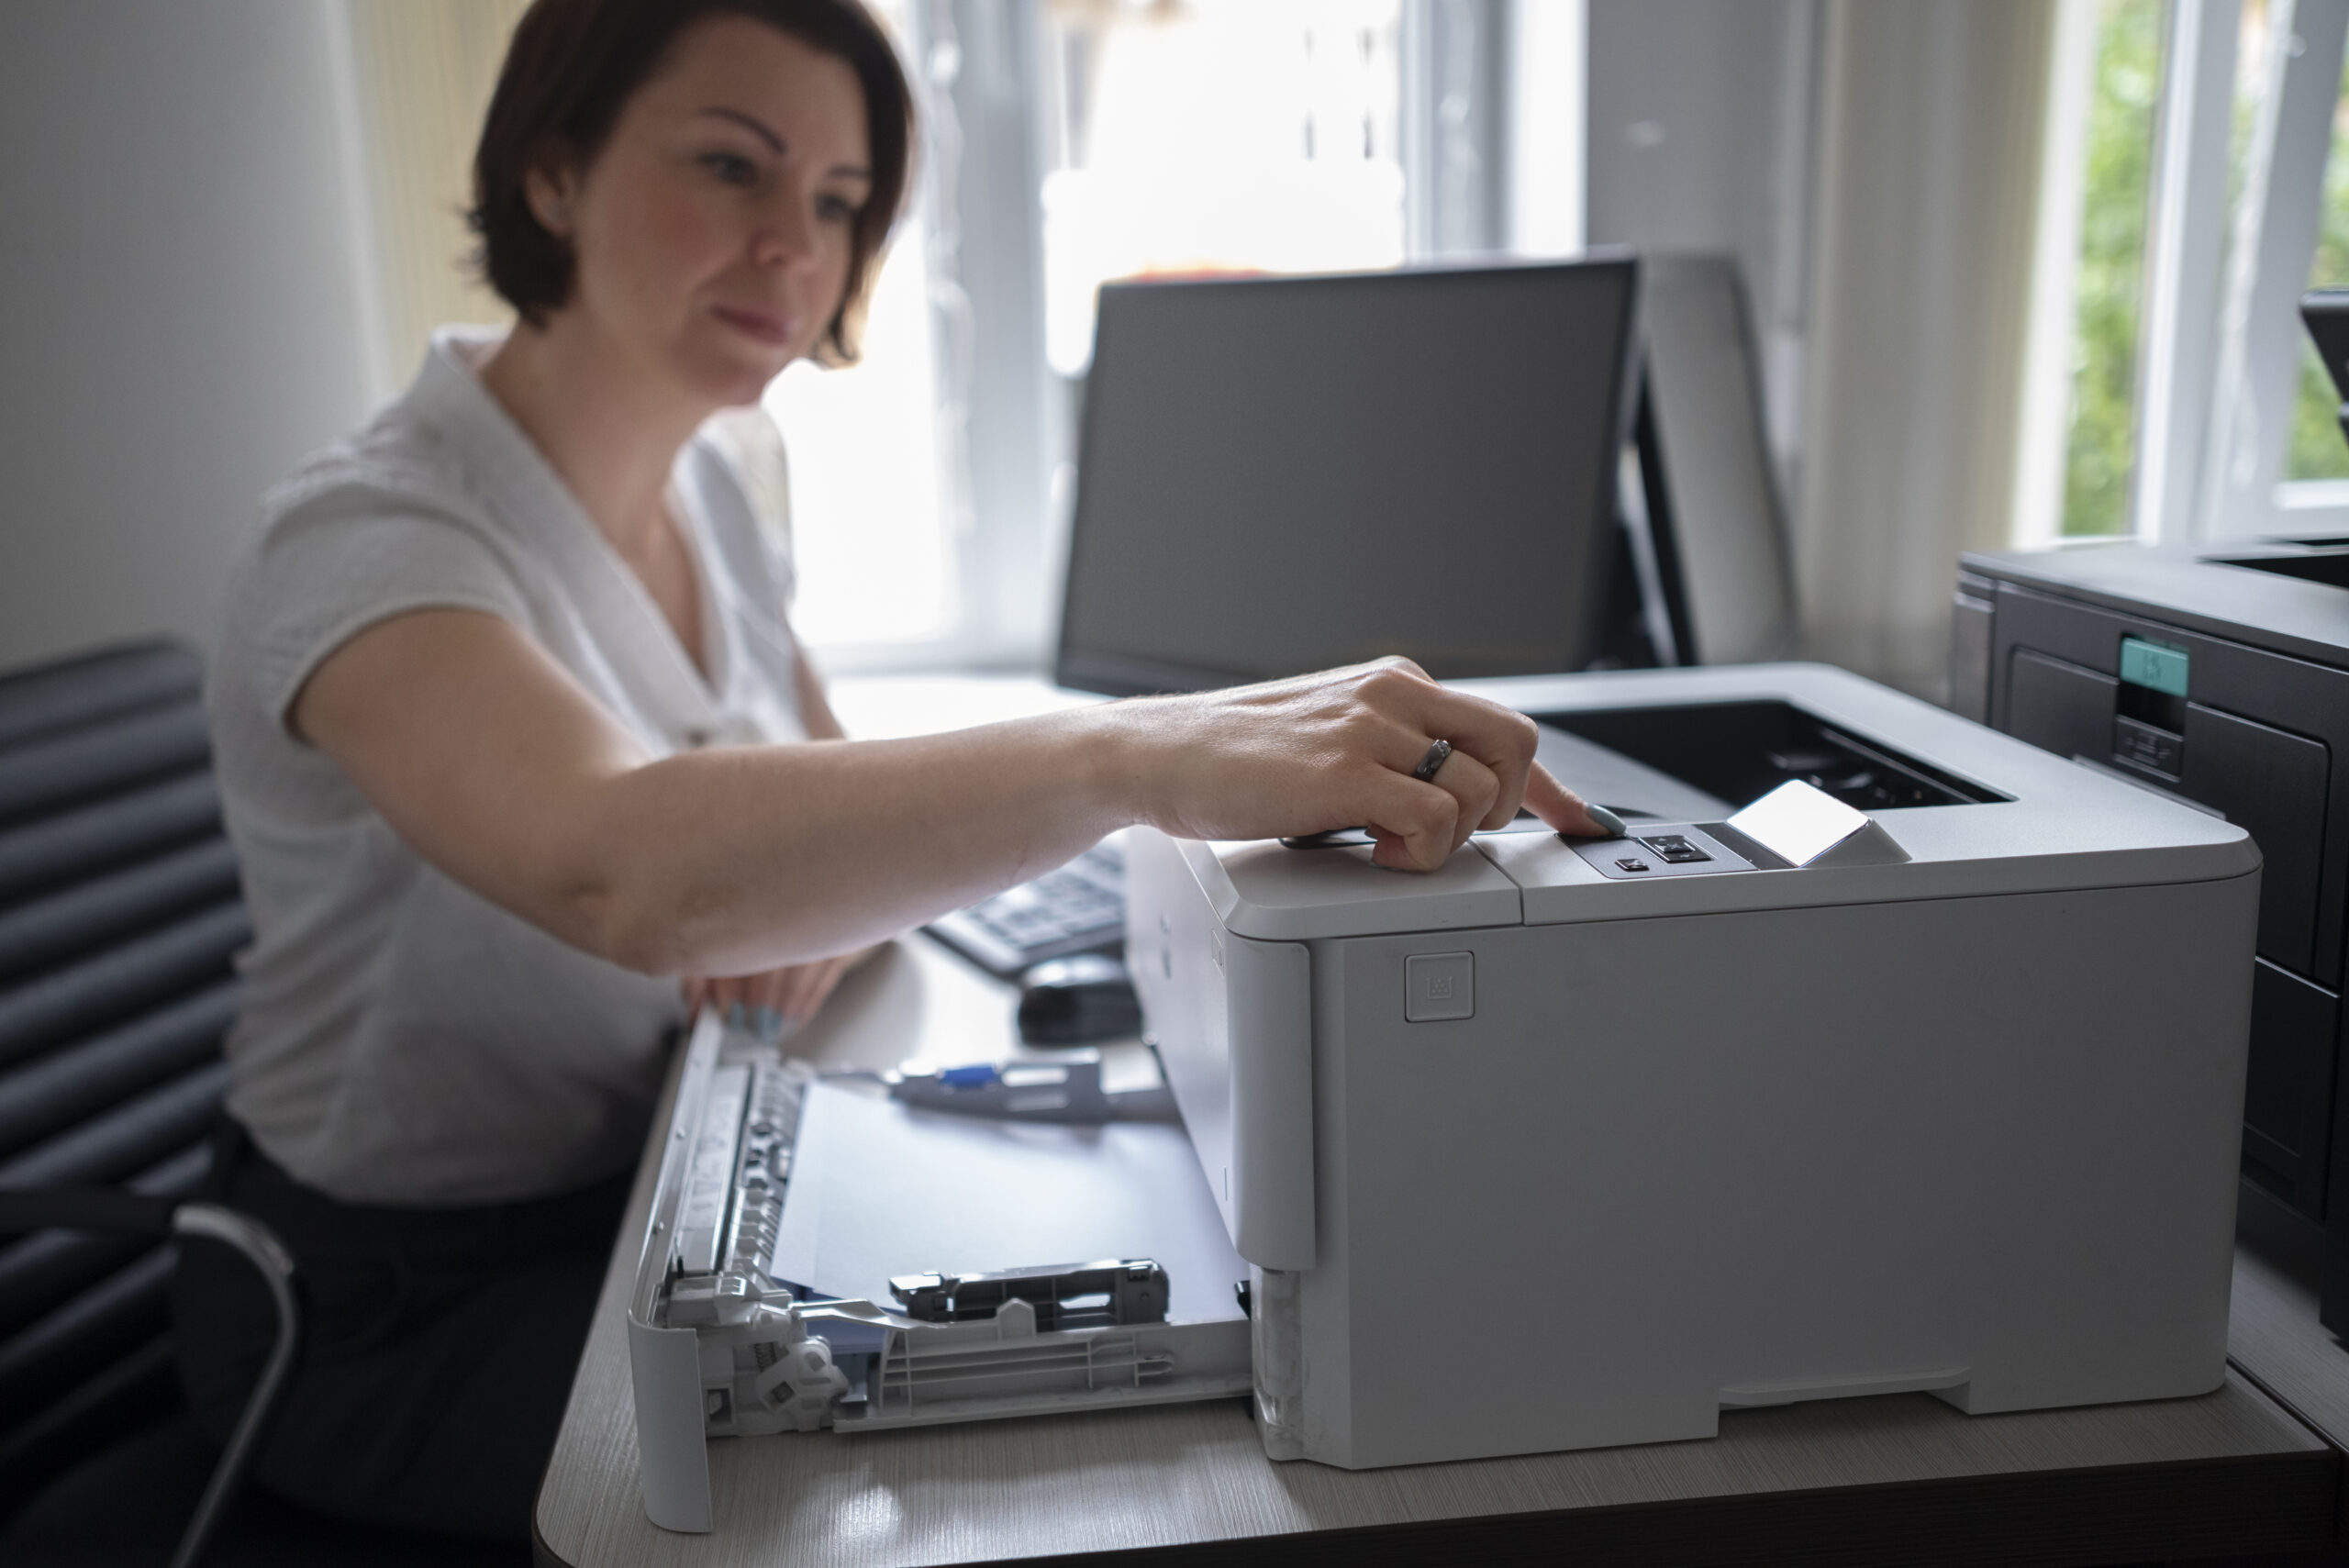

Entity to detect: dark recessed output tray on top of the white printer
[1534,702,2010,812]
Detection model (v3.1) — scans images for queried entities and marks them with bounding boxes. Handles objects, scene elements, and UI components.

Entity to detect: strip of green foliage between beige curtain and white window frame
[2063,0,2151,535]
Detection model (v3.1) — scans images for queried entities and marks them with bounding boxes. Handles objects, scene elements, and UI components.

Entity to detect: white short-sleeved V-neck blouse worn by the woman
[206,328,806,1207]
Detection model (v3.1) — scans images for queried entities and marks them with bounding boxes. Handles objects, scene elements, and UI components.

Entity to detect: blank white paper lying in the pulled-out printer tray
[768,1082,1247,1321]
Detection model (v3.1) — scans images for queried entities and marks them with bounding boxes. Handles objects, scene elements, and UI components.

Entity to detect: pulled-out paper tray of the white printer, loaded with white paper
[628,1014,1252,1530]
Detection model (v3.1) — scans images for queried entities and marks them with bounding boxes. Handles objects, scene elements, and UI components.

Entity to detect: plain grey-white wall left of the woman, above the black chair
[0,0,369,669]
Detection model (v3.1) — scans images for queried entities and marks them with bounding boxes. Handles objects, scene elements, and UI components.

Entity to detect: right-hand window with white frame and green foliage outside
[2015,0,2349,545]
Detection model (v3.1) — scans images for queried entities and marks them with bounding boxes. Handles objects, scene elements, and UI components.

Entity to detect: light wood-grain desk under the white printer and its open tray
[536,939,2340,1568]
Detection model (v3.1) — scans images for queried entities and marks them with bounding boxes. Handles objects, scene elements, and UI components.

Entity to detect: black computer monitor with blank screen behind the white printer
[1054,256,1637,695]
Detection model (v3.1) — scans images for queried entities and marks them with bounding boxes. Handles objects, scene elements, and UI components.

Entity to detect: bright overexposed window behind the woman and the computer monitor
[768,0,1586,672]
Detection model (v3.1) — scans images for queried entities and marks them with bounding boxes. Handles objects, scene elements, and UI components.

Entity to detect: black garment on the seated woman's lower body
[173,1122,629,1540]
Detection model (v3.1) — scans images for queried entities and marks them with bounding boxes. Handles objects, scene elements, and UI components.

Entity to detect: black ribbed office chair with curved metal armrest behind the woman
[0,643,521,1565]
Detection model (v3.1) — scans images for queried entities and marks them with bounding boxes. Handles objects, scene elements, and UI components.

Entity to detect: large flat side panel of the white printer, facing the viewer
[1301,875,2257,1467]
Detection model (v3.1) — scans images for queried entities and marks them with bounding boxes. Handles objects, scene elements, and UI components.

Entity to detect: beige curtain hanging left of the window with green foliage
[1795,0,2055,697]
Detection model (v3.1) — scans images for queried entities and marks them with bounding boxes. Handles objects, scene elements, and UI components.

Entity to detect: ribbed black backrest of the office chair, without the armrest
[0,643,249,1512]
